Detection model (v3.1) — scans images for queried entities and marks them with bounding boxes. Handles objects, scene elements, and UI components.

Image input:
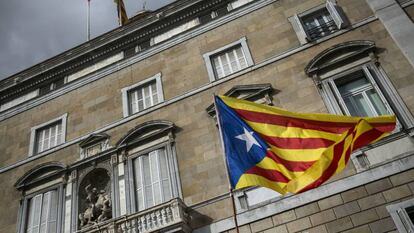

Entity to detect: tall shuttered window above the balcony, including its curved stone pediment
[117,120,181,213]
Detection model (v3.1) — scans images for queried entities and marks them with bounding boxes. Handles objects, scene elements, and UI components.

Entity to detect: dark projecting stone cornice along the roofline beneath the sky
[0,0,229,100]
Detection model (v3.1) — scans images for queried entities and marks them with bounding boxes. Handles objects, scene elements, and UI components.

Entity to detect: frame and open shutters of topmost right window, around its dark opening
[288,0,349,45]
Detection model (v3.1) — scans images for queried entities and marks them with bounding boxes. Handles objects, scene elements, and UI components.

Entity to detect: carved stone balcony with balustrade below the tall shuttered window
[77,198,191,233]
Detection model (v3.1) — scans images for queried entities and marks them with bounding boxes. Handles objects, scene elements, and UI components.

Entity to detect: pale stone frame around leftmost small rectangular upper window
[29,113,68,157]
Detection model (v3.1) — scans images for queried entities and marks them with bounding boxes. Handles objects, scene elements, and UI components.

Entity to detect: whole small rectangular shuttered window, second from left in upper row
[122,73,164,117]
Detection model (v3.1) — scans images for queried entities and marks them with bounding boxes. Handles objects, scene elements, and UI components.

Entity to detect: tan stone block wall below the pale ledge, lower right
[223,170,414,233]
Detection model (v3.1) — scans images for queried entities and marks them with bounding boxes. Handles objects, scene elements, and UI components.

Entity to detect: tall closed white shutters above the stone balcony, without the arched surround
[134,148,173,211]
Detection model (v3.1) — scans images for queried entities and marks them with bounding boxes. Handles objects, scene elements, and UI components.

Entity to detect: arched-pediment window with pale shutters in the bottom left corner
[15,162,66,233]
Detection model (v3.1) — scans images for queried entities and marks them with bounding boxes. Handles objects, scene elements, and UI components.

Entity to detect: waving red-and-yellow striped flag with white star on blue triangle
[215,96,396,194]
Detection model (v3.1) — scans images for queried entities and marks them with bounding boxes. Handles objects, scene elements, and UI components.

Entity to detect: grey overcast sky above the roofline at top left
[0,0,174,80]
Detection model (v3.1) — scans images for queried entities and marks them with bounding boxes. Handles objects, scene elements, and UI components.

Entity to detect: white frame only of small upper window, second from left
[121,73,164,117]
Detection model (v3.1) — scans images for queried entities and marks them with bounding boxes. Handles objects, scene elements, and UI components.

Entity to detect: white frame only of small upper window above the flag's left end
[203,37,254,82]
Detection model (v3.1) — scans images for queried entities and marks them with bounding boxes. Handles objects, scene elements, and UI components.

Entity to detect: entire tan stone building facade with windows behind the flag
[0,0,414,233]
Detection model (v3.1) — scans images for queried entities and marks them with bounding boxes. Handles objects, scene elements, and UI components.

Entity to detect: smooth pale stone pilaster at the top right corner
[366,0,414,67]
